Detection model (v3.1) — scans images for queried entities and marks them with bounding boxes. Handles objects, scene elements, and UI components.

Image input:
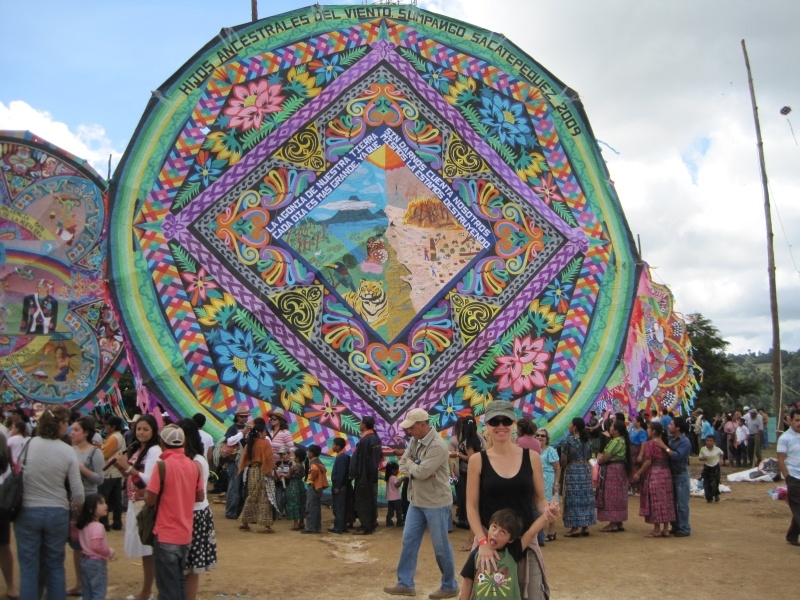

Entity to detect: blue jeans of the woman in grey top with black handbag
[14,507,69,600]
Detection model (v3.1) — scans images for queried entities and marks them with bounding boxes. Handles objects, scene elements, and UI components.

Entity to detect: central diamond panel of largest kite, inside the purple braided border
[184,59,575,418]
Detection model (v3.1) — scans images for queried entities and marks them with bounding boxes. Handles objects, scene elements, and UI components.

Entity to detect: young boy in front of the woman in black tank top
[460,508,558,600]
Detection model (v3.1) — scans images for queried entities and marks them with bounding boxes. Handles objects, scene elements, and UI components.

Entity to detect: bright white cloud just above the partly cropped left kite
[0,100,122,179]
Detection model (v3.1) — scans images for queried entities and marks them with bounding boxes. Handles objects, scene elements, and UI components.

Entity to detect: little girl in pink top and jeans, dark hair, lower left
[76,494,114,600]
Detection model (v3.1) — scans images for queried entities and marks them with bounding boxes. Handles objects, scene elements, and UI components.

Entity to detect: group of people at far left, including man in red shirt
[0,405,217,600]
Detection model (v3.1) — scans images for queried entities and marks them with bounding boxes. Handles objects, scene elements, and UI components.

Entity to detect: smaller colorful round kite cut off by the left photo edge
[0,131,126,411]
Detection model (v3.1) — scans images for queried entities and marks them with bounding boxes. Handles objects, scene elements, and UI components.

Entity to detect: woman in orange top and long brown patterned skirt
[239,417,275,533]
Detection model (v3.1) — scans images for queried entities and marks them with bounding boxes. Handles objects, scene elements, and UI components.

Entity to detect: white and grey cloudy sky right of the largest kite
[412,0,800,352]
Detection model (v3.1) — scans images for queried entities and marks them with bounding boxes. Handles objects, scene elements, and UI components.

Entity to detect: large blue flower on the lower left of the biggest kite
[214,328,277,392]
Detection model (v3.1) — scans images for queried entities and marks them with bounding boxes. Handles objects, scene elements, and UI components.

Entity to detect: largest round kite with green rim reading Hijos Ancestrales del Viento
[111,6,686,444]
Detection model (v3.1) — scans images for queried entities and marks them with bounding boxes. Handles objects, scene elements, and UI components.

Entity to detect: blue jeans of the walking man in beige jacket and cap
[397,504,458,590]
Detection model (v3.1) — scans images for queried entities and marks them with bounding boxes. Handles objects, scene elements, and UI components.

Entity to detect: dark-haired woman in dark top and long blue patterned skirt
[561,417,596,538]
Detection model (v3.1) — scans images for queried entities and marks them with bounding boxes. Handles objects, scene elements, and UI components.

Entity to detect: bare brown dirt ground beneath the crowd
[10,469,800,600]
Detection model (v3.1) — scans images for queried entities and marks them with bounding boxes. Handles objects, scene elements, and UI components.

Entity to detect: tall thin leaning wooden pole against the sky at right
[742,40,783,418]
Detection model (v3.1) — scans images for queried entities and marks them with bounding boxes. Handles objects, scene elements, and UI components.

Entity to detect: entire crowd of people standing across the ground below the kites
[0,400,800,600]
